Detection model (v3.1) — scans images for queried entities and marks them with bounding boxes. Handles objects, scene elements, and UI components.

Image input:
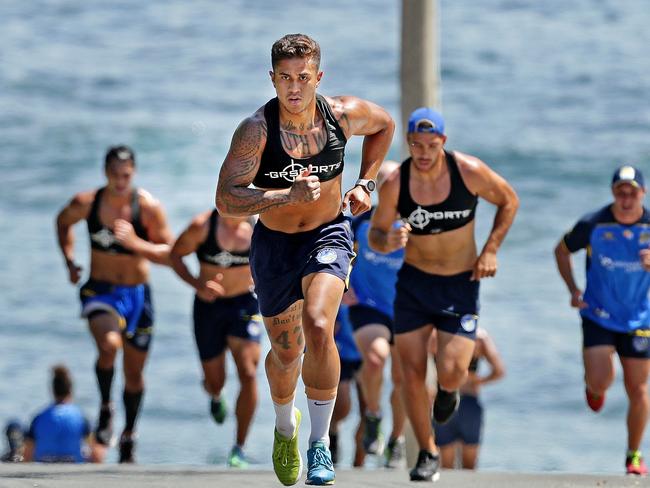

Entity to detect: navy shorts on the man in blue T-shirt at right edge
[582,317,650,359]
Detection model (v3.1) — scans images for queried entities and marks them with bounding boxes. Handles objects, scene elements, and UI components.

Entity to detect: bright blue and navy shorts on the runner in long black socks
[79,278,154,351]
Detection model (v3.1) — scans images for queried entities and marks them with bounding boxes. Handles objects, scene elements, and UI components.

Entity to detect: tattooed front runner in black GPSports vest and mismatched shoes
[216,34,394,485]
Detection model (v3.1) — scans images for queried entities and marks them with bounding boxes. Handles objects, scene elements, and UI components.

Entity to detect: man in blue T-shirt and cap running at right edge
[555,166,650,475]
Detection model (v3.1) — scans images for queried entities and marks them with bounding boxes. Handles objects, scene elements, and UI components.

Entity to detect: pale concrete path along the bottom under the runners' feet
[0,464,650,488]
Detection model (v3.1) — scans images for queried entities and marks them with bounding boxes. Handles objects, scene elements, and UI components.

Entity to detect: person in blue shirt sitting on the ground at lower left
[24,365,106,463]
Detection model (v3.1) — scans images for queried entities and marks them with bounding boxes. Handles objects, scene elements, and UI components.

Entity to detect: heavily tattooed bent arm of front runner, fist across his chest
[216,110,320,217]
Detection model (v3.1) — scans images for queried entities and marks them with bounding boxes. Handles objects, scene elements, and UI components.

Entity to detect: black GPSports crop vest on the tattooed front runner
[253,94,347,188]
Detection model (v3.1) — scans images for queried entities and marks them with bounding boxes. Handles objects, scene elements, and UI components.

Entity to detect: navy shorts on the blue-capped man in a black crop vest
[394,263,479,339]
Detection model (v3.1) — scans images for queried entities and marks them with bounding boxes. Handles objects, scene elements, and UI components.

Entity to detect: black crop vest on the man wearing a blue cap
[397,151,478,235]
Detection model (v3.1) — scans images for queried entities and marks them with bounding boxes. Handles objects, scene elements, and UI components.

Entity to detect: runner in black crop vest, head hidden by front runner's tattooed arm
[170,210,262,468]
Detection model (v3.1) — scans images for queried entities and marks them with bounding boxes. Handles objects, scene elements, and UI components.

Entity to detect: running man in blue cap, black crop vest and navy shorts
[369,108,519,481]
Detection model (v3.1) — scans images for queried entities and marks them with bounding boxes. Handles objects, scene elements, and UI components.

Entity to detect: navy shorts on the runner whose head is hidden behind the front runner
[194,293,262,361]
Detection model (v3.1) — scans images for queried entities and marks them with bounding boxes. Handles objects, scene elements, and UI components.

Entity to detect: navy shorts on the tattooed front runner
[250,214,355,317]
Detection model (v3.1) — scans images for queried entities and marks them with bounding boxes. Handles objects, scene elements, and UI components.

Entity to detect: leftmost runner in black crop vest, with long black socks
[56,146,172,462]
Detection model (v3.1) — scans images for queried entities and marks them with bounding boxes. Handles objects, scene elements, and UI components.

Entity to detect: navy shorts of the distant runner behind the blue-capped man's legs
[433,395,483,447]
